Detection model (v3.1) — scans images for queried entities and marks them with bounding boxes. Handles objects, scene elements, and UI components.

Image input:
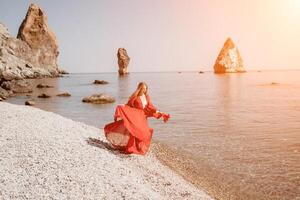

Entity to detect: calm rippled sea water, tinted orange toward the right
[8,71,300,199]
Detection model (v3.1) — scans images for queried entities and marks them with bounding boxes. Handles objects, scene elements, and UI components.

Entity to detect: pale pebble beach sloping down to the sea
[0,102,212,199]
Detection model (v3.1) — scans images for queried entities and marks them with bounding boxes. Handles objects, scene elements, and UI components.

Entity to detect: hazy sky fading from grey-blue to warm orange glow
[0,0,300,72]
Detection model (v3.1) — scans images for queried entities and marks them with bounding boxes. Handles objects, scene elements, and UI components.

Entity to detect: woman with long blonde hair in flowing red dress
[104,82,170,154]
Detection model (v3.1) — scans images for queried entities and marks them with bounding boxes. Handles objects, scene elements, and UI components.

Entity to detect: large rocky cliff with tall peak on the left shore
[0,4,59,80]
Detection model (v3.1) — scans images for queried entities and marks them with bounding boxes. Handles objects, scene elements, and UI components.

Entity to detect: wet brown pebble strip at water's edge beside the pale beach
[151,141,234,200]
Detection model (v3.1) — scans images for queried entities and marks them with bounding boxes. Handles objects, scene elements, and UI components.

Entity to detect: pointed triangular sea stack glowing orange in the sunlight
[214,38,245,73]
